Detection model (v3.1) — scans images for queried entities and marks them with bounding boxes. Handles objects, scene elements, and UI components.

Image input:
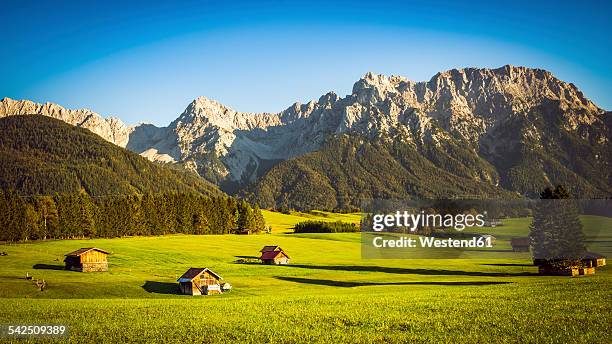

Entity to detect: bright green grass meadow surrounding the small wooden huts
[0,212,612,343]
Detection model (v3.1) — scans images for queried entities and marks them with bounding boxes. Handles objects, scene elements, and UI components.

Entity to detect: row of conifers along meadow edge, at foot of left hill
[0,190,265,241]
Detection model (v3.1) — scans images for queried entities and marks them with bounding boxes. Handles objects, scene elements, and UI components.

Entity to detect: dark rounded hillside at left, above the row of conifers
[0,115,221,196]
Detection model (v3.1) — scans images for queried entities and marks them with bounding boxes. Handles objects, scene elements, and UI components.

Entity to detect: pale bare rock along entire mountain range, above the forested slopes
[0,66,610,199]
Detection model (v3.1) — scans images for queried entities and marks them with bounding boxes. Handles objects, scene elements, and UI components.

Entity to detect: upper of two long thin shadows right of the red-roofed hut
[272,264,538,277]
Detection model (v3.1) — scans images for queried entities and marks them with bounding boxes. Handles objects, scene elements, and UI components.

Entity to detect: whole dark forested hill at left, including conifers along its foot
[0,116,265,241]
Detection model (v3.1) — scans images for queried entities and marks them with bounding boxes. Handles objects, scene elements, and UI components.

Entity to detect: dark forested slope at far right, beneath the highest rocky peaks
[480,107,612,198]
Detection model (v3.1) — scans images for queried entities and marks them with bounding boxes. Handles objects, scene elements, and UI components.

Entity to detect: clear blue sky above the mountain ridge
[0,0,612,125]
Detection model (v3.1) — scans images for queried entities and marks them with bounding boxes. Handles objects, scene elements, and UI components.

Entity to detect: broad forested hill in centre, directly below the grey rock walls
[247,136,518,210]
